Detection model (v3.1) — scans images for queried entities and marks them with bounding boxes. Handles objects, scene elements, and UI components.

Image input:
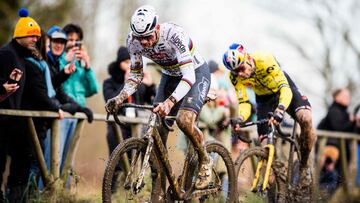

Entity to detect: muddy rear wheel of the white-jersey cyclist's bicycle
[186,141,237,203]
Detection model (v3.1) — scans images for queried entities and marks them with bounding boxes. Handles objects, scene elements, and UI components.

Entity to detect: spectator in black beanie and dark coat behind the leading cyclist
[103,46,156,190]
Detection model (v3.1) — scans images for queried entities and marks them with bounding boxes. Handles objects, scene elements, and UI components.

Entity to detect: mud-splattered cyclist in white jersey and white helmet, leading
[105,5,212,192]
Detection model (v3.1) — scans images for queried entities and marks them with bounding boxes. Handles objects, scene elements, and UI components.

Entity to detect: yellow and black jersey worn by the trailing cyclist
[229,51,293,120]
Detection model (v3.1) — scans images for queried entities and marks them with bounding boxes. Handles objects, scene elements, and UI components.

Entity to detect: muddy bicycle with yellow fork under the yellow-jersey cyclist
[231,116,301,202]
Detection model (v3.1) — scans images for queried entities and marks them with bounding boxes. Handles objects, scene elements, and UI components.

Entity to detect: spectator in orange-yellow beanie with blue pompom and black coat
[0,9,41,202]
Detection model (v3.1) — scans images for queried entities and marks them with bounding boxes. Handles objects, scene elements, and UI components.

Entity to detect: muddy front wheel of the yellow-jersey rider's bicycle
[235,147,285,202]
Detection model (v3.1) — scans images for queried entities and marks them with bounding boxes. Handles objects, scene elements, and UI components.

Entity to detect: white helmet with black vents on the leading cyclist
[130,5,159,37]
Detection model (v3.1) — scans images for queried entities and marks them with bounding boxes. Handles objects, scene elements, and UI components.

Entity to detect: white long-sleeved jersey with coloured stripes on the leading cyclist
[127,23,204,77]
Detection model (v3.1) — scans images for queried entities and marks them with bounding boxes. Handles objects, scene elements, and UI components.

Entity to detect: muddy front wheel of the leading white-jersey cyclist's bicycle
[102,138,154,203]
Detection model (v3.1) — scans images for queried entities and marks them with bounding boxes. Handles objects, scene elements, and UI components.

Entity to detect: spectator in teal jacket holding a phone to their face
[59,24,99,186]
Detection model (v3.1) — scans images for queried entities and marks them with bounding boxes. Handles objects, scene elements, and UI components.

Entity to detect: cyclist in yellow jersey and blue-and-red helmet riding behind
[223,44,316,186]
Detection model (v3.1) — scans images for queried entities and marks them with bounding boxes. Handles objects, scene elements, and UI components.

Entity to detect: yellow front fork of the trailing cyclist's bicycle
[251,144,275,192]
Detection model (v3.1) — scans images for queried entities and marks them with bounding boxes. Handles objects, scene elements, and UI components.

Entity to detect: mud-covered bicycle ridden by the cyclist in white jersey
[102,104,237,203]
